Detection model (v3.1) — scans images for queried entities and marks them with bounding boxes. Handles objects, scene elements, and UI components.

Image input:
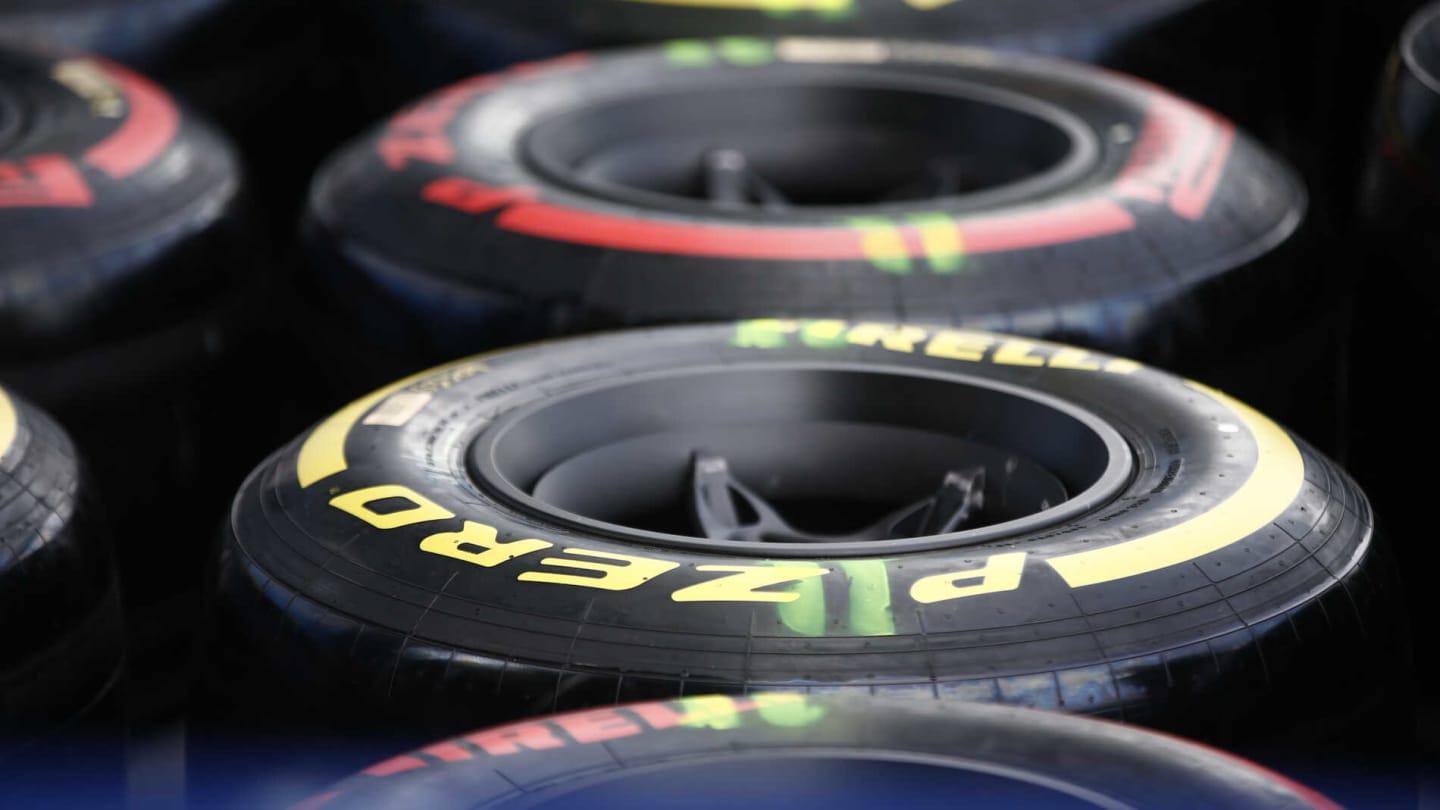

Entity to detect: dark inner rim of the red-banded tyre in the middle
[521,76,1099,216]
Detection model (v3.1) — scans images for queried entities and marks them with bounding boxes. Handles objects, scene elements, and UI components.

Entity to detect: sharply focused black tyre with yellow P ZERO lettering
[207,320,1404,747]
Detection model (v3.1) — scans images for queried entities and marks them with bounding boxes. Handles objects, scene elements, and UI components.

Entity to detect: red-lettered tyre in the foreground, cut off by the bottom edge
[295,693,1338,810]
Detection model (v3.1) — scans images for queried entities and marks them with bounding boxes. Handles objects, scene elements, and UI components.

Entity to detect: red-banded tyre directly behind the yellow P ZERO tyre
[297,39,1344,447]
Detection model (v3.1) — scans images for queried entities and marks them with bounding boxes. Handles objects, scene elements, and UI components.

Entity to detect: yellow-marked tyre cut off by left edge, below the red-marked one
[0,389,125,807]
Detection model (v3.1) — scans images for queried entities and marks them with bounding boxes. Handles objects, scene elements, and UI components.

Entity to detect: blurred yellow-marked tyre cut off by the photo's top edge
[354,0,1221,82]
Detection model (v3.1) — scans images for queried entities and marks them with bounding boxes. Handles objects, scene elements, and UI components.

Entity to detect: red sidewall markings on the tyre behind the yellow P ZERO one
[397,70,1236,261]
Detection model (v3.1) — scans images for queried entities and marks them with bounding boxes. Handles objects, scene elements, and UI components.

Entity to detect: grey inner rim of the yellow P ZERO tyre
[469,366,1133,556]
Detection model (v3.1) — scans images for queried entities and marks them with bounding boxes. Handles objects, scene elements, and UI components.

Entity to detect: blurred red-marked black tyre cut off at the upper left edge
[0,42,240,354]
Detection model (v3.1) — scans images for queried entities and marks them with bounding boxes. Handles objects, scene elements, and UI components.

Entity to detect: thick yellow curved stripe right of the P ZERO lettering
[1050,382,1305,588]
